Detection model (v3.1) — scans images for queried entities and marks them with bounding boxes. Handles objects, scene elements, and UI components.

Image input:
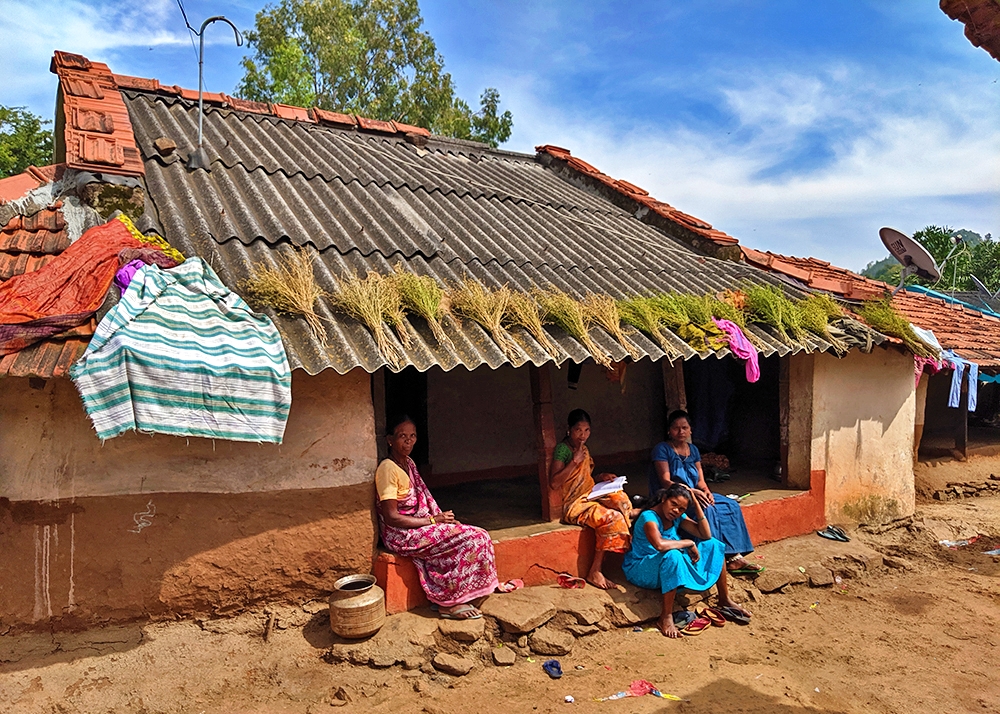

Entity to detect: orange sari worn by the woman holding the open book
[552,443,632,553]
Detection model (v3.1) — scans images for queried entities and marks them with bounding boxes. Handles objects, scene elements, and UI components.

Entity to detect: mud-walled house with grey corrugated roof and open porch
[0,53,913,626]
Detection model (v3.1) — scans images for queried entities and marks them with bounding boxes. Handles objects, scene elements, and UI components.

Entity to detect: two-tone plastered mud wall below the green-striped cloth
[0,371,376,632]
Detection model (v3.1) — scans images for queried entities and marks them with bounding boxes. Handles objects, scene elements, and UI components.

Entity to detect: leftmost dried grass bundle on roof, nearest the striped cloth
[240,249,327,347]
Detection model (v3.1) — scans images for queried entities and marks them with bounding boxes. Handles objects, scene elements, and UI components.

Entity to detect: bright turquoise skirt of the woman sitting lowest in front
[622,538,726,593]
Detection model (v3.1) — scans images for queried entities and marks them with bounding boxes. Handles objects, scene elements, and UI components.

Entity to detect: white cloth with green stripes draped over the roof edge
[70,258,292,444]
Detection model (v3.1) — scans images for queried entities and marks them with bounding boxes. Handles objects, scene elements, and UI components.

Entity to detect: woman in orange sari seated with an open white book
[549,409,632,590]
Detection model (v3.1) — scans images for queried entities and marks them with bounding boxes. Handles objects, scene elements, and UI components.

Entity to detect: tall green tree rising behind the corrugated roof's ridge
[236,0,513,147]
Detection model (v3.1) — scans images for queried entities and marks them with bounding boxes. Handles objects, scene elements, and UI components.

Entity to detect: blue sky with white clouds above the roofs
[0,0,1000,269]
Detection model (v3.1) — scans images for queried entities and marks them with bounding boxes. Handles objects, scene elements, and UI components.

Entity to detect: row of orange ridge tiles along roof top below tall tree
[114,62,431,136]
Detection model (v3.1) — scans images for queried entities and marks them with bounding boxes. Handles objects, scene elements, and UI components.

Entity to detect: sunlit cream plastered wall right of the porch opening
[812,348,916,523]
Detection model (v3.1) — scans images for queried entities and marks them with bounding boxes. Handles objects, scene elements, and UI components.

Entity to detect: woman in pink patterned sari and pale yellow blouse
[375,416,498,620]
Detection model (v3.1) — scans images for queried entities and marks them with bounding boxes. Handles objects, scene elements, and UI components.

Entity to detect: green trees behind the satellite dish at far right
[861,226,1000,292]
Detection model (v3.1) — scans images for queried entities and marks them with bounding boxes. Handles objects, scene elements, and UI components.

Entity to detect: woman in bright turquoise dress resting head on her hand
[622,483,750,638]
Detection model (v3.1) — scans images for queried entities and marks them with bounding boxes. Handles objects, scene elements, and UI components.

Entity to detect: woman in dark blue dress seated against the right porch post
[649,409,763,575]
